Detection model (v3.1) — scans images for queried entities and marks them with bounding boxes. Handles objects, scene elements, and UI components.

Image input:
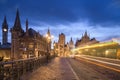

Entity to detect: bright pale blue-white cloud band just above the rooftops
[27,21,120,42]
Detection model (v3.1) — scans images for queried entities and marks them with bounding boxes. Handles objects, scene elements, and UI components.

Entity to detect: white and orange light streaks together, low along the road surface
[78,57,120,73]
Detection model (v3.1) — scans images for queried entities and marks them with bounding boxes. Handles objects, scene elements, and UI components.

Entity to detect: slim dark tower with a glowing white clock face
[2,16,8,45]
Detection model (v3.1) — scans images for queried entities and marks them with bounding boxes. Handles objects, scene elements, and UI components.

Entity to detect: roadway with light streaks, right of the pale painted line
[67,55,120,80]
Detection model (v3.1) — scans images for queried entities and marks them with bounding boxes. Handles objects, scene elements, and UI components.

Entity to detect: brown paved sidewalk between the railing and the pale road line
[21,57,76,80]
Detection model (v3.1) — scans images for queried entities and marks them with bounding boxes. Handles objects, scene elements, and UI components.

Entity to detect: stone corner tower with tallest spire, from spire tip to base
[11,9,24,59]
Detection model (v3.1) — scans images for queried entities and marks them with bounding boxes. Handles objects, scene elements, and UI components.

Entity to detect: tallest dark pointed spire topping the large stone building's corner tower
[13,8,22,30]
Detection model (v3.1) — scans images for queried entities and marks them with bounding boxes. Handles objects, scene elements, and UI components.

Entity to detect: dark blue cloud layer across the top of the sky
[0,0,120,27]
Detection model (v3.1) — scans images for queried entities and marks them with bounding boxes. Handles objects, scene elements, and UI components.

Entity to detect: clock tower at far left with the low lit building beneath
[0,16,11,59]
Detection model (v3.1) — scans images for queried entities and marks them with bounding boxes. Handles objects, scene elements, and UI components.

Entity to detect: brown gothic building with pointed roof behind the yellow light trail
[75,31,99,47]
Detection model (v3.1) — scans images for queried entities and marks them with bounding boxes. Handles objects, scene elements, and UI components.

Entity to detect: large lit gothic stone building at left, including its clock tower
[0,9,51,60]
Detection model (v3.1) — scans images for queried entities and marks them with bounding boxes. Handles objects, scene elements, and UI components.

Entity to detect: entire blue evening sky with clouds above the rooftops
[0,0,120,43]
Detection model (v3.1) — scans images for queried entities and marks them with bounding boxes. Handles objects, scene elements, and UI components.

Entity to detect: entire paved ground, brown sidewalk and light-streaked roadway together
[21,55,120,80]
